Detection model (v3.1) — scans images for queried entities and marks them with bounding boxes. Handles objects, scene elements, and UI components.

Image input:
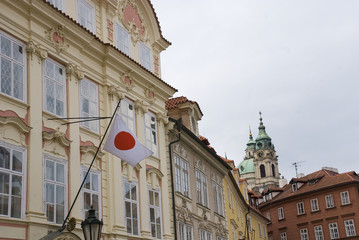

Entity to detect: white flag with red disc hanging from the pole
[103,114,153,166]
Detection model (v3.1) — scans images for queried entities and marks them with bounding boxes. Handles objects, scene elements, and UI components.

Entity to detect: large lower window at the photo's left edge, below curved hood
[0,142,26,218]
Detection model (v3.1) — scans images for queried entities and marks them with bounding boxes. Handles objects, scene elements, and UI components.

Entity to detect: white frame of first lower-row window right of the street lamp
[123,179,141,236]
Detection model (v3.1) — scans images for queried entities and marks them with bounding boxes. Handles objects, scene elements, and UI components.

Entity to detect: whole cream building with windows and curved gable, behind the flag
[0,0,176,239]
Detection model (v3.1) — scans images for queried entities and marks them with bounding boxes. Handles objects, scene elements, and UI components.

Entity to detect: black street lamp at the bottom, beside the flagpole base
[81,205,103,240]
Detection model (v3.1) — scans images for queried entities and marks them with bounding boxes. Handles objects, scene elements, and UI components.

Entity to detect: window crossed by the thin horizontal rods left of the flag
[80,78,99,132]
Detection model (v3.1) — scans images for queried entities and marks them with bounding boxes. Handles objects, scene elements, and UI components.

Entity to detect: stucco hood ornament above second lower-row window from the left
[42,128,71,156]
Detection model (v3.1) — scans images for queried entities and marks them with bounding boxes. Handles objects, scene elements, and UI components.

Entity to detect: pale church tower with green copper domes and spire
[238,113,280,193]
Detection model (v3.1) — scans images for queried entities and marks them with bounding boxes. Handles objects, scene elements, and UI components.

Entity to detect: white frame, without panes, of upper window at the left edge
[0,30,27,102]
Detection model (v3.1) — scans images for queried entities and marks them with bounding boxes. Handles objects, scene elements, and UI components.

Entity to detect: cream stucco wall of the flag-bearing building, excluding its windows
[0,1,176,239]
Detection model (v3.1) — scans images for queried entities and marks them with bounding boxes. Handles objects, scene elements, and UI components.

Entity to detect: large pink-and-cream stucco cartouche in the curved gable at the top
[119,0,149,46]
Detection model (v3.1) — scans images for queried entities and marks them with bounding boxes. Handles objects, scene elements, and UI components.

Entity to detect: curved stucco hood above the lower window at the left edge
[0,116,32,146]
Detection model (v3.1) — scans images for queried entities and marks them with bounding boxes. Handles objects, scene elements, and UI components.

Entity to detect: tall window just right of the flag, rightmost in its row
[145,113,157,156]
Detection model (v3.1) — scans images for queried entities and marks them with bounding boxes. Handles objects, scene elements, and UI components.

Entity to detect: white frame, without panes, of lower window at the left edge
[0,140,27,219]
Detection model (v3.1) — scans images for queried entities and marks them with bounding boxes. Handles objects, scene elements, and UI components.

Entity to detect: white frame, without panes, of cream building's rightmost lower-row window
[148,187,162,239]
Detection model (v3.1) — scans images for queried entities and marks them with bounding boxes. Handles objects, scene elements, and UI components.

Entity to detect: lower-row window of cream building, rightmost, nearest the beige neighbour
[148,189,162,239]
